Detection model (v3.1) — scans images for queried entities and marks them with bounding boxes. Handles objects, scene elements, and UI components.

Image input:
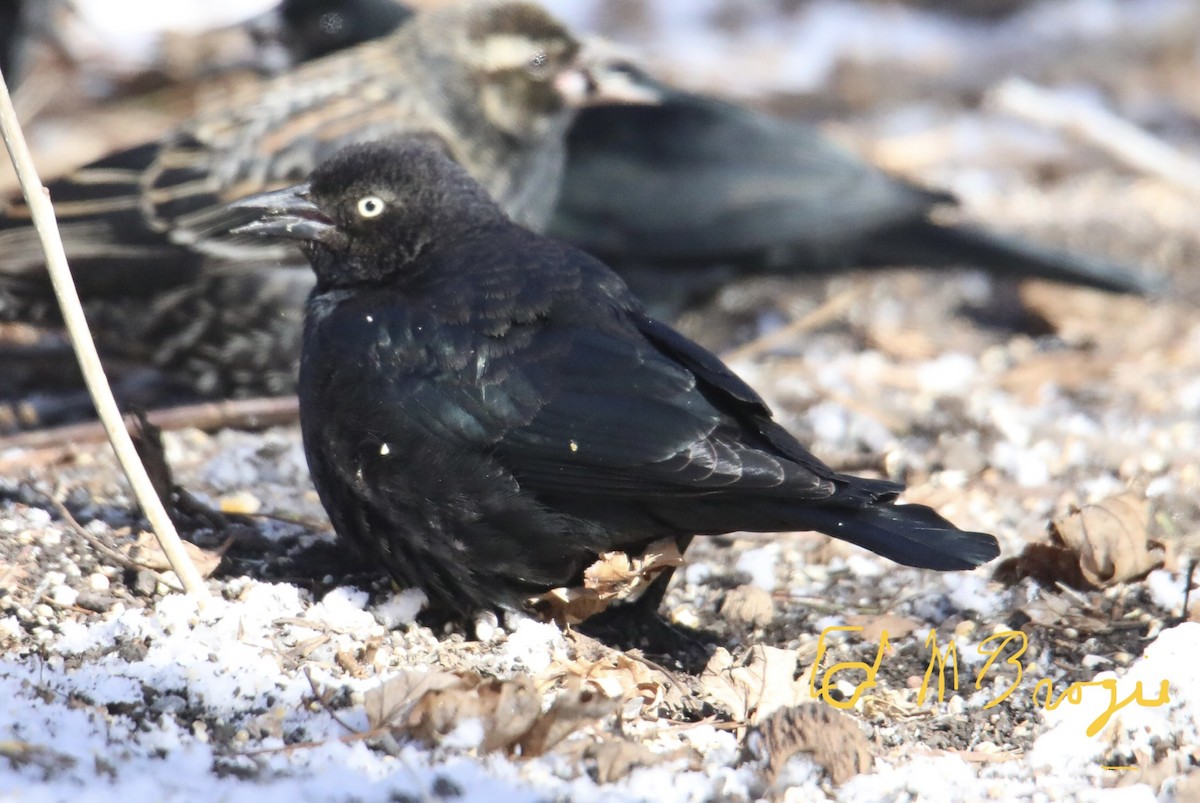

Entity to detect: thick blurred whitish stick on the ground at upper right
[988,78,1200,193]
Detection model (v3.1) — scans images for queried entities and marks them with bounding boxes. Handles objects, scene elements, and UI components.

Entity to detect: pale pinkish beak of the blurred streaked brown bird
[554,38,664,108]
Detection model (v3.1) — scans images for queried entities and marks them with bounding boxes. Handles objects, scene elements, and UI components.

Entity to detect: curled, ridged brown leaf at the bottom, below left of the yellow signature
[746,705,874,785]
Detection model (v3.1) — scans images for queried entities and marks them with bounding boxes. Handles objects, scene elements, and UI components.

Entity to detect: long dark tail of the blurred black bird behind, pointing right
[868,221,1168,295]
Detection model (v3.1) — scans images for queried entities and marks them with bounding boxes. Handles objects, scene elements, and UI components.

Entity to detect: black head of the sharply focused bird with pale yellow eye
[232,138,504,288]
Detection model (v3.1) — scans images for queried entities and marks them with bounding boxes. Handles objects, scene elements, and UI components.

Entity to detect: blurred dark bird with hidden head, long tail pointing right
[548,67,1164,312]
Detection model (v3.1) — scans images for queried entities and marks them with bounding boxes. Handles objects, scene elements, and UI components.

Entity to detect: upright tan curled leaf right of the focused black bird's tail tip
[1050,493,1164,588]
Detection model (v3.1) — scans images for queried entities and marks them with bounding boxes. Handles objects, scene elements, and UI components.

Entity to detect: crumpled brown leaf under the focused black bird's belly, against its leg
[532,539,683,624]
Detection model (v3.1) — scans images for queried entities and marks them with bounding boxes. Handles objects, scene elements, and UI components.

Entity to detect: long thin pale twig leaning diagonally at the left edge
[0,64,209,605]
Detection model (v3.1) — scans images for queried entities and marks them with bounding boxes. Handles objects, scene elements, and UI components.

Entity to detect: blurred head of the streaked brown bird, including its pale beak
[410,0,659,140]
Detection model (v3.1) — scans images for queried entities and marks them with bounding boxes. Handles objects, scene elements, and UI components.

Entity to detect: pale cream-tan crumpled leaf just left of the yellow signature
[700,645,812,724]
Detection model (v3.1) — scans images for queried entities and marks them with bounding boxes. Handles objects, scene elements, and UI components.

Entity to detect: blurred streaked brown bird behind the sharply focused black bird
[0,0,644,396]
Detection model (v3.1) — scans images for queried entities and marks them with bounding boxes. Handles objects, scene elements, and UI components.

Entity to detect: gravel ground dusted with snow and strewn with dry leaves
[0,0,1200,801]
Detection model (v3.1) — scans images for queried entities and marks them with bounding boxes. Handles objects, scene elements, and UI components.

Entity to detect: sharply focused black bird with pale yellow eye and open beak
[229,142,998,615]
